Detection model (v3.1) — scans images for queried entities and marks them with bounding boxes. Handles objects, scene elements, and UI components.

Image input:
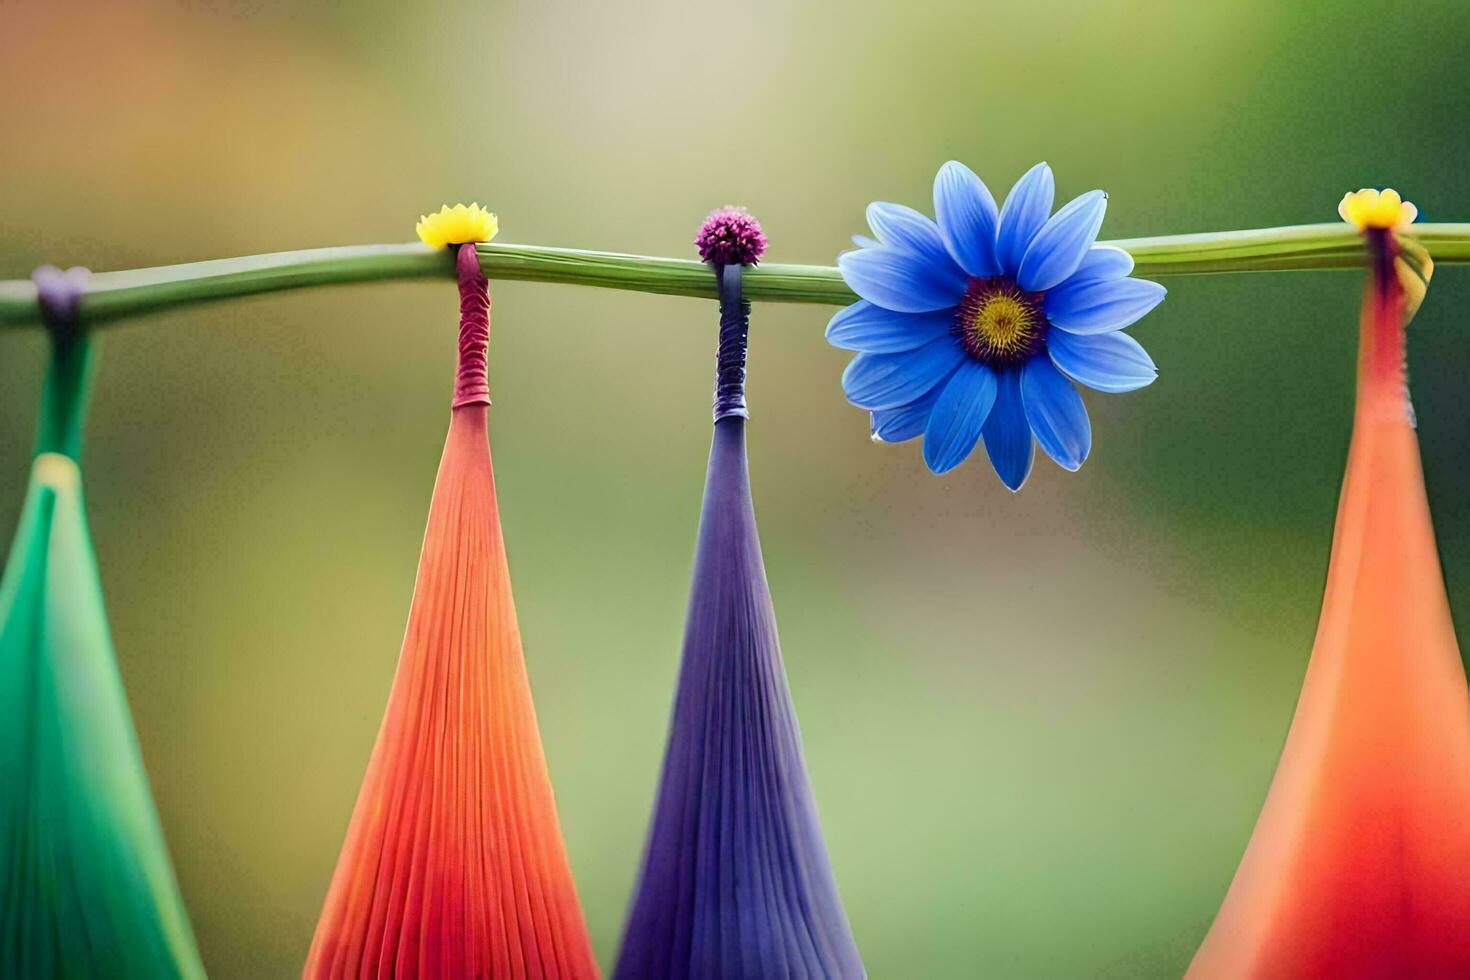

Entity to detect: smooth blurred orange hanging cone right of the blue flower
[1189,231,1470,980]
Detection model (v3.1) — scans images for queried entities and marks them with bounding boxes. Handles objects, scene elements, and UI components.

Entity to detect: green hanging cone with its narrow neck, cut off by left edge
[0,336,204,980]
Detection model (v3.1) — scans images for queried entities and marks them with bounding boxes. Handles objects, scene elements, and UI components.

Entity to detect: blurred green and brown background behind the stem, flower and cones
[0,0,1470,979]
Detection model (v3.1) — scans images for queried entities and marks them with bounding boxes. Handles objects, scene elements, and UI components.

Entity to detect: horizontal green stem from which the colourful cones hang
[0,223,1470,328]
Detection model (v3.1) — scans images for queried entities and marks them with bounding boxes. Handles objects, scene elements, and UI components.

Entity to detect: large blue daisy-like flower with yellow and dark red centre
[826,160,1164,491]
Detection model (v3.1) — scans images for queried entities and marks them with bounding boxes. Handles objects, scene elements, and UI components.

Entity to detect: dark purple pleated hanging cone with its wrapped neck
[616,266,864,980]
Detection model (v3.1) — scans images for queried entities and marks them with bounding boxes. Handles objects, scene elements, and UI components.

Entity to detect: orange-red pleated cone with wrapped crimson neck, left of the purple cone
[304,245,597,980]
